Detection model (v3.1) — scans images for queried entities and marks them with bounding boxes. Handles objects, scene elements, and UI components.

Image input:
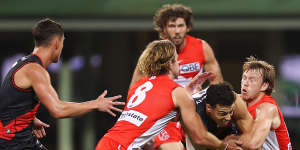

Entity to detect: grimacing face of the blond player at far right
[241,70,264,101]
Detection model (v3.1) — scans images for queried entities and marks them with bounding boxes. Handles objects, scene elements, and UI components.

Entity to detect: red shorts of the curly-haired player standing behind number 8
[154,121,185,148]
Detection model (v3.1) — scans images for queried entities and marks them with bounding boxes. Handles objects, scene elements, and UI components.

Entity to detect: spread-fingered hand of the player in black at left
[96,90,125,117]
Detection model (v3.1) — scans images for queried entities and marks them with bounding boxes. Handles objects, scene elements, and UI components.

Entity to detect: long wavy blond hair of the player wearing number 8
[137,40,176,76]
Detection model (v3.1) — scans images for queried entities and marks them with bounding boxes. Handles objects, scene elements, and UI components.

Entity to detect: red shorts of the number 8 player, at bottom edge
[95,136,126,150]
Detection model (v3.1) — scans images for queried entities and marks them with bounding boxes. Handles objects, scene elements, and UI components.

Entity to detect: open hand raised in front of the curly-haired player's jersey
[185,72,214,94]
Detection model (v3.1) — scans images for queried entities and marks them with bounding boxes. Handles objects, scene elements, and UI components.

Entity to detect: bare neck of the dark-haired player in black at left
[32,47,52,68]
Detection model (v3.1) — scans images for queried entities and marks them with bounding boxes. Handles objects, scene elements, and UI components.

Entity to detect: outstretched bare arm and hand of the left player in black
[22,64,125,118]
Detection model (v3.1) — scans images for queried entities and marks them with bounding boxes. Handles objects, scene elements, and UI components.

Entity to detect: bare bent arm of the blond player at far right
[241,103,280,149]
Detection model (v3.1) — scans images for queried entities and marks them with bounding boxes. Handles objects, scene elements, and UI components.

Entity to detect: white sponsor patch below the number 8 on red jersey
[118,110,148,127]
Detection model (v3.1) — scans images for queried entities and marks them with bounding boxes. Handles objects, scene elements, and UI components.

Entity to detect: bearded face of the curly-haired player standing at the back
[165,18,189,47]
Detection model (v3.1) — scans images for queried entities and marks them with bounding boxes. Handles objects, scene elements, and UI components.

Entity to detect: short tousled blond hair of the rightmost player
[243,56,275,95]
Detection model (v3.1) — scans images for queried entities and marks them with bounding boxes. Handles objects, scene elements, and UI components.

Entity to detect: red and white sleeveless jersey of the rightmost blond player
[248,95,292,150]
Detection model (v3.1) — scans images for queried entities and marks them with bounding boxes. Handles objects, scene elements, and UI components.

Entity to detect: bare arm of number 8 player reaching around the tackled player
[172,87,238,149]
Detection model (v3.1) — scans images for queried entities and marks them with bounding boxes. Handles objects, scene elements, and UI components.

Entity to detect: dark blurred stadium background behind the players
[0,0,300,150]
